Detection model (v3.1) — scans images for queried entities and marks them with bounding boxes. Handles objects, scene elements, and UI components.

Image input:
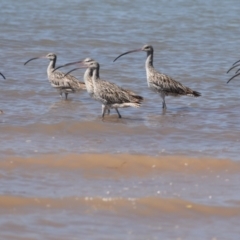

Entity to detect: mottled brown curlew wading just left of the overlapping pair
[24,53,86,99]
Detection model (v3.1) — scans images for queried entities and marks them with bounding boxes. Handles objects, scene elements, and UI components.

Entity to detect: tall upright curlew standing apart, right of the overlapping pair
[114,45,201,109]
